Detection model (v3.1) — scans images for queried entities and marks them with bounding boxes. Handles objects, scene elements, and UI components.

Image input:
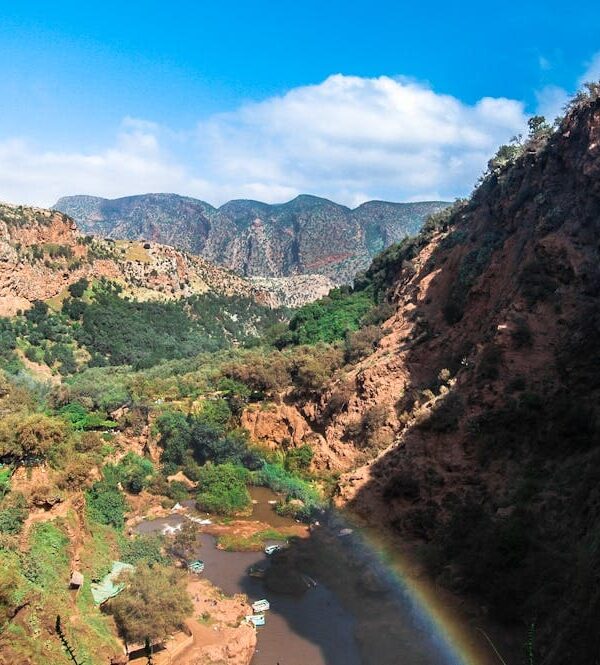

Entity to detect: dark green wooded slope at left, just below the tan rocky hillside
[0,280,285,376]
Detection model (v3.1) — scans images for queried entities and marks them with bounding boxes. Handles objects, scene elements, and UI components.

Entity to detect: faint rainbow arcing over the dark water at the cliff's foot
[342,525,507,665]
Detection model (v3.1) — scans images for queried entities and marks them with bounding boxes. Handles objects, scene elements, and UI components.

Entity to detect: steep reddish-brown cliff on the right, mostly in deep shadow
[258,93,600,665]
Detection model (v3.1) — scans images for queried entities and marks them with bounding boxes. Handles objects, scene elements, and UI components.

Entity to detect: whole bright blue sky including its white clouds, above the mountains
[0,0,600,205]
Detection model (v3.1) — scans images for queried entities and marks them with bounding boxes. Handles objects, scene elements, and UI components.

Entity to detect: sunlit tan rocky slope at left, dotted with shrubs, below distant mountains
[0,204,281,316]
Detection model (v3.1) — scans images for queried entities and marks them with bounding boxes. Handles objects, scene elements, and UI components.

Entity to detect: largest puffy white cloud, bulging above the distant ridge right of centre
[197,75,525,201]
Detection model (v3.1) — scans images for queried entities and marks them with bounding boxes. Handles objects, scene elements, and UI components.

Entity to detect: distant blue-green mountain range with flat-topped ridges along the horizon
[53,194,448,286]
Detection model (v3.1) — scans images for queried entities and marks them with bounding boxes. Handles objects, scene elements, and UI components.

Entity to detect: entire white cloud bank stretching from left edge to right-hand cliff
[0,74,526,205]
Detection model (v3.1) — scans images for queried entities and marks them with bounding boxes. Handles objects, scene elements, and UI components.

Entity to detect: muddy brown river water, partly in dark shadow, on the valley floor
[136,488,459,665]
